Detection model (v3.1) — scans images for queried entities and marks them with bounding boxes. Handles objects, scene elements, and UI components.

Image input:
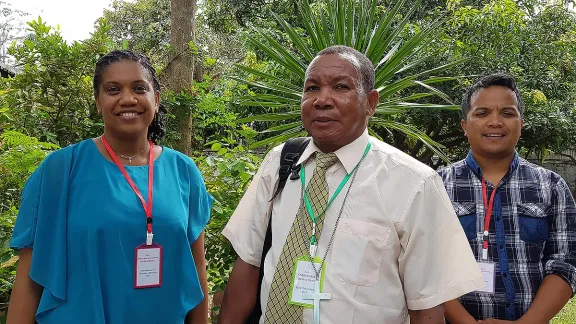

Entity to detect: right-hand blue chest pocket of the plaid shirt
[517,203,548,245]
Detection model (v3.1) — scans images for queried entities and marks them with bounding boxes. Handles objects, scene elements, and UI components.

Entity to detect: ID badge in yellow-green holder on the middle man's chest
[288,256,326,308]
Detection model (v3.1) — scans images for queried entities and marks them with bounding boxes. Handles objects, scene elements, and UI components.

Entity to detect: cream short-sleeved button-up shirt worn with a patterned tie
[223,132,484,324]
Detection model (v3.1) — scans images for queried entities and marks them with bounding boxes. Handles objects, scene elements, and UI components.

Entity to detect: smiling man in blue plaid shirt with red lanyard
[439,75,576,324]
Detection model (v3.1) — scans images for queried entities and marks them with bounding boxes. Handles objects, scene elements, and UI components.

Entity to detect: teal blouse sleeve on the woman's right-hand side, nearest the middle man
[187,163,214,245]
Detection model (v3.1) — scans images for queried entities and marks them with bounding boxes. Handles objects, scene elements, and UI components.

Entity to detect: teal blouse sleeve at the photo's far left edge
[10,164,44,250]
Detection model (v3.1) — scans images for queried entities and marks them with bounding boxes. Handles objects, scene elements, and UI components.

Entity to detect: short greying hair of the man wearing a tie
[306,45,375,94]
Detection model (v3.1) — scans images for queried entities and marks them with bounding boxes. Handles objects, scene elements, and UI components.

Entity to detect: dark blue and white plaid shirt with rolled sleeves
[439,153,576,321]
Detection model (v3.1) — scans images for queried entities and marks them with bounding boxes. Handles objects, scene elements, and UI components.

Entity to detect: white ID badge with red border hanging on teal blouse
[134,243,162,289]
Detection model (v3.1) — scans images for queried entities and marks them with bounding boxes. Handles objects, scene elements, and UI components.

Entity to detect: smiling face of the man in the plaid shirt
[462,86,524,159]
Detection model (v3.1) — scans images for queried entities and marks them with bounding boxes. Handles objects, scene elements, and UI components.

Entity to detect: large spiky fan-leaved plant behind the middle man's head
[237,0,462,159]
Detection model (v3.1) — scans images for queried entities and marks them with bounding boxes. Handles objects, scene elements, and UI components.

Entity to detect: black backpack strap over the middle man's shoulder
[246,137,310,324]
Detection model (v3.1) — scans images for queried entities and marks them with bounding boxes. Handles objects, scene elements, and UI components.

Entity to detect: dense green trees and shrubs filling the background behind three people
[0,0,576,322]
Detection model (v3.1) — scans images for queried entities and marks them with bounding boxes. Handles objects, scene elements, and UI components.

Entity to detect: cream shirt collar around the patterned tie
[298,129,370,174]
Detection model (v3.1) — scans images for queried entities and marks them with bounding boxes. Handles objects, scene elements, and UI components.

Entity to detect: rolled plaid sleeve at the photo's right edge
[543,178,576,296]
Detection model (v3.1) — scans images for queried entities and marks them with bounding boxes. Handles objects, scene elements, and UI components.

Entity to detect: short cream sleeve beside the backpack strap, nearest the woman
[222,148,281,267]
